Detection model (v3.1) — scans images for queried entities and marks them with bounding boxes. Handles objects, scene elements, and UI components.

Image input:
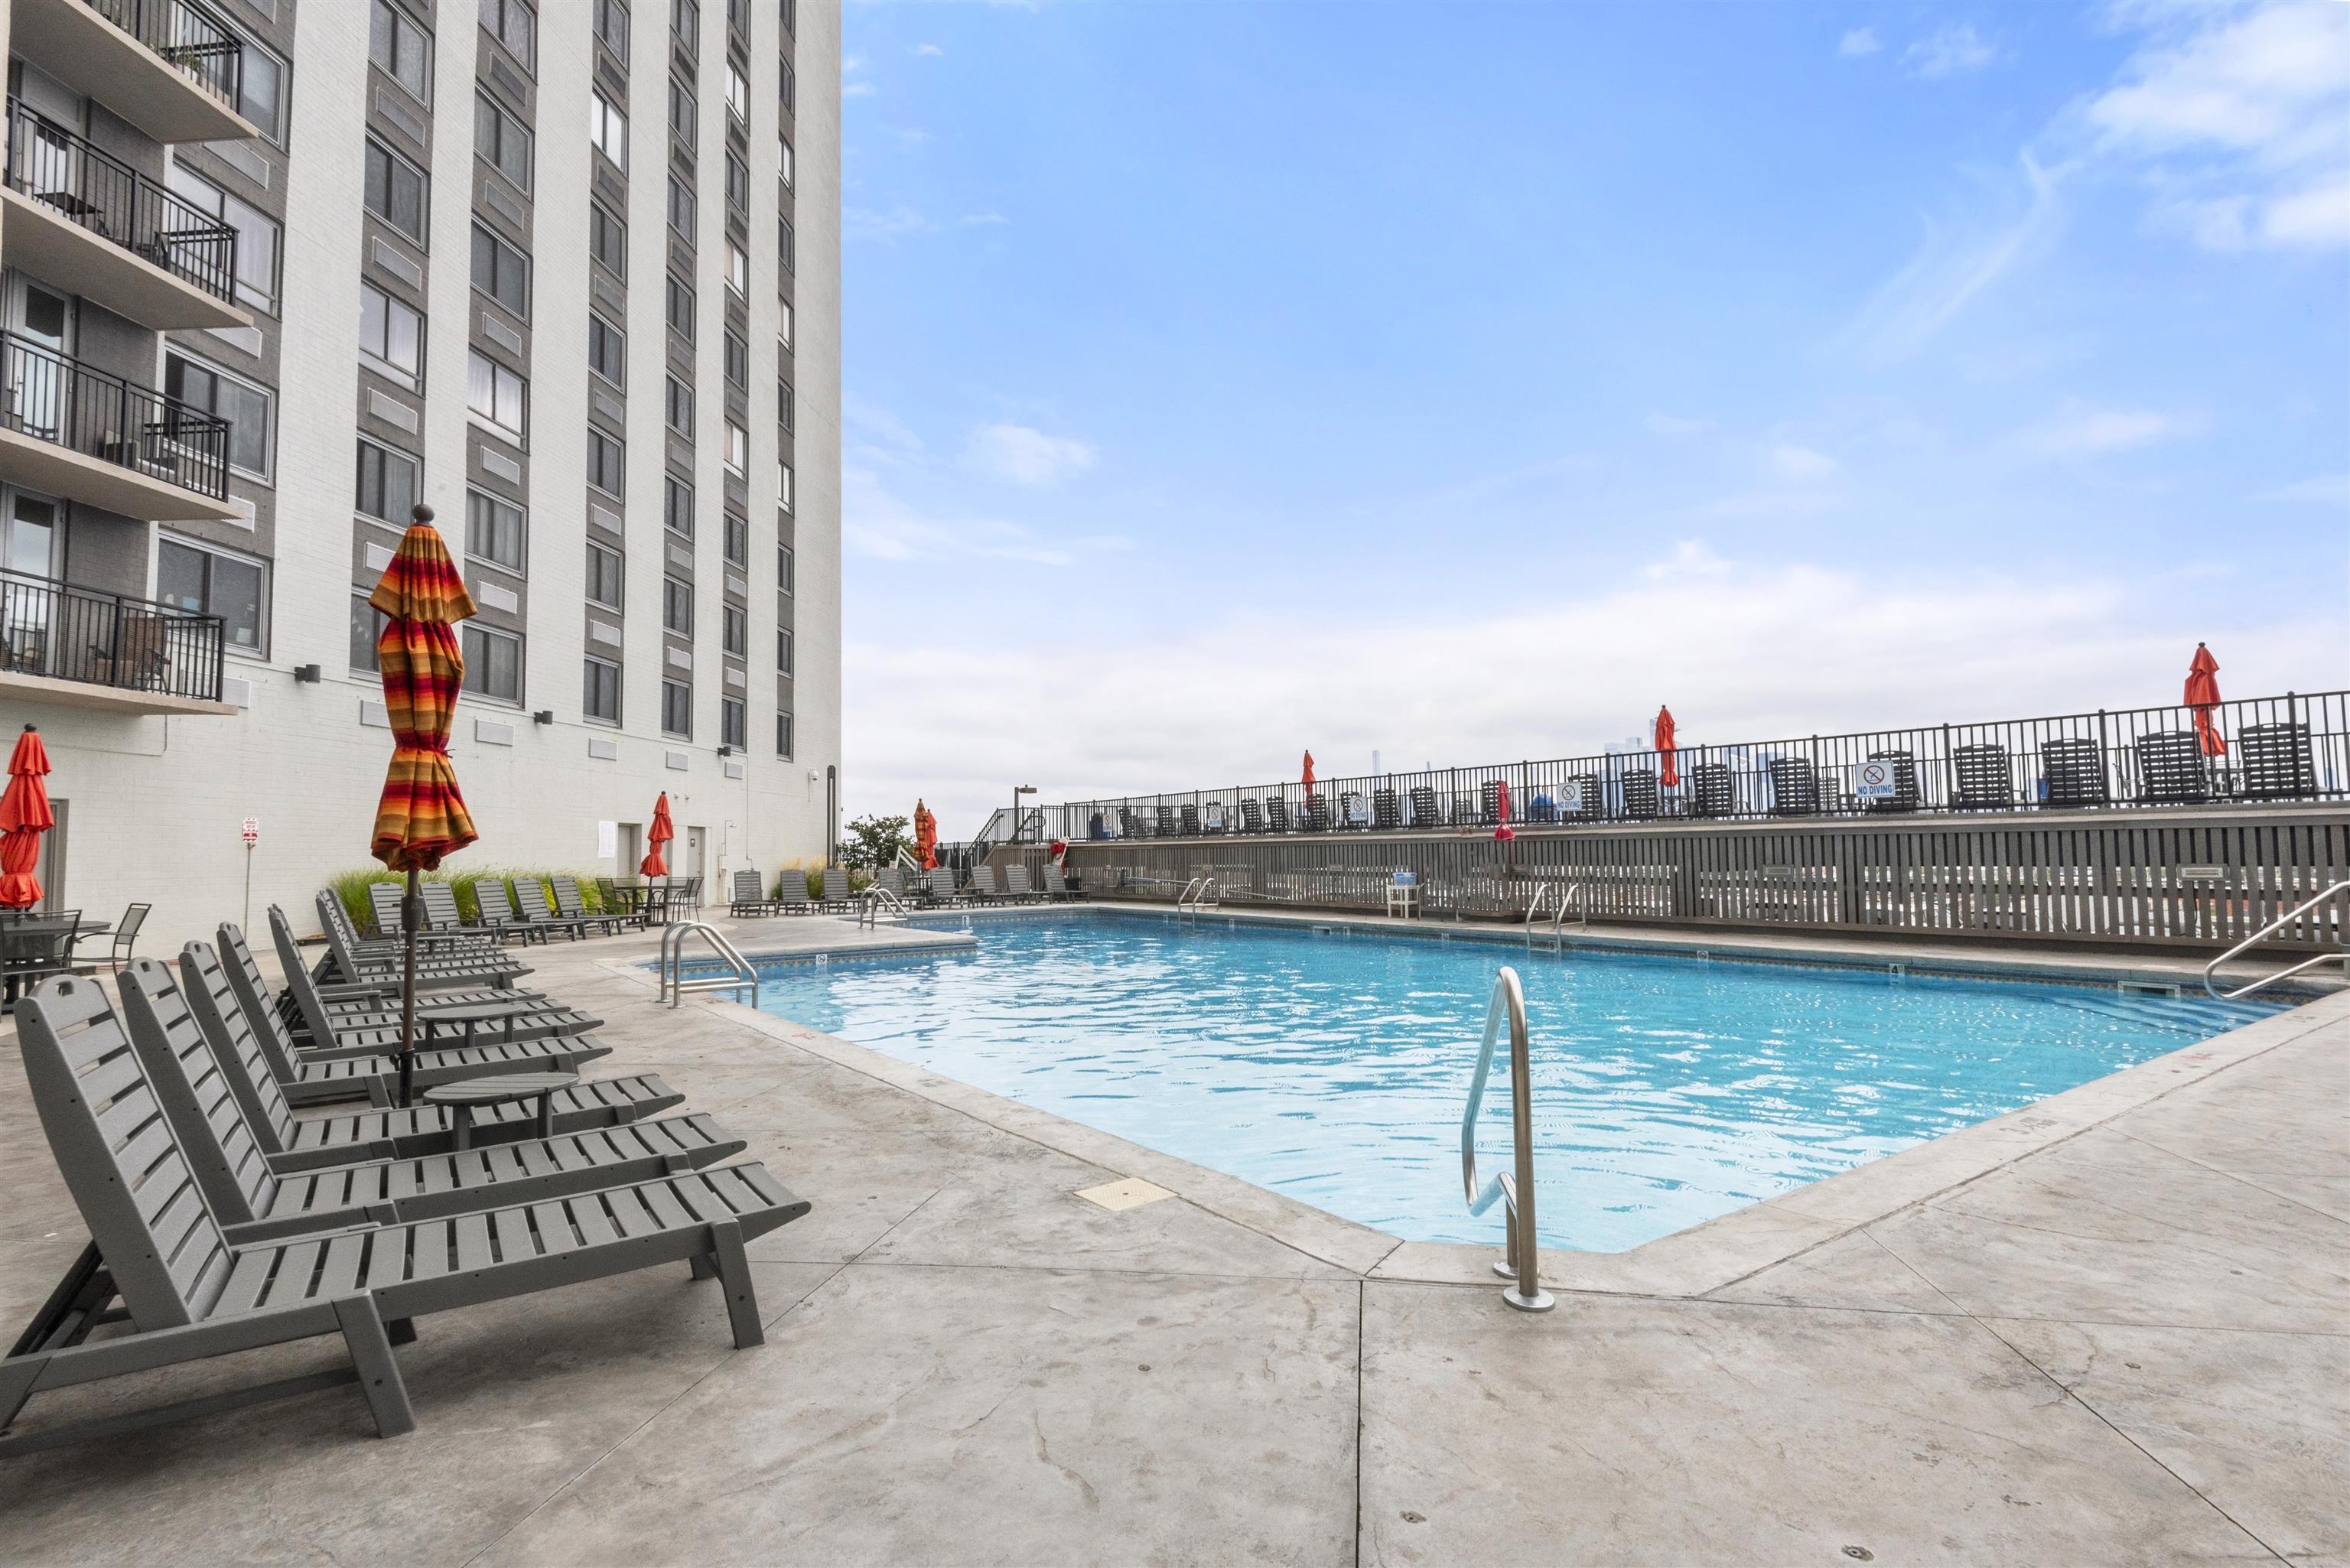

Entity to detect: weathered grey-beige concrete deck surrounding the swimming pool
[0,919,2350,1566]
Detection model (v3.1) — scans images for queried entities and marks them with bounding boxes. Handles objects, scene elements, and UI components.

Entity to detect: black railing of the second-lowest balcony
[0,331,228,501]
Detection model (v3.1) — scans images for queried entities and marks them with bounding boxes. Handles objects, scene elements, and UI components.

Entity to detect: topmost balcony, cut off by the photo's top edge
[9,0,261,141]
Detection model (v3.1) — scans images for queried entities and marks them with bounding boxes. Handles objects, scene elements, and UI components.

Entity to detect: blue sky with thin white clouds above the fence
[844,5,2350,837]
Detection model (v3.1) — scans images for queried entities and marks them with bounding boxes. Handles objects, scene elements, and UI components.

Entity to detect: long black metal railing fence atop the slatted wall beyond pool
[1053,691,2350,844]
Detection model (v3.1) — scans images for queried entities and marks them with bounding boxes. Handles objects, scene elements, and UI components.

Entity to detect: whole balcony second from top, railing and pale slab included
[0,99,254,331]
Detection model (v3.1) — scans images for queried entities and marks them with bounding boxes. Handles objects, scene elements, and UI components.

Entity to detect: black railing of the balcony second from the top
[7,99,237,303]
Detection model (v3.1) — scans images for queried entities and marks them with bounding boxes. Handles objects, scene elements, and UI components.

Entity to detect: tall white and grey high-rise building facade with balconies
[0,0,841,952]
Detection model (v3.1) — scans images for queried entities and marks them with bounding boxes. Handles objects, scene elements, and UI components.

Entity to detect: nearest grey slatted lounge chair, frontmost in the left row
[0,978,809,1455]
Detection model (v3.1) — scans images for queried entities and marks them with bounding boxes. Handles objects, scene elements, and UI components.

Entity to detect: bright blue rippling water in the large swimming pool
[759,915,2275,1251]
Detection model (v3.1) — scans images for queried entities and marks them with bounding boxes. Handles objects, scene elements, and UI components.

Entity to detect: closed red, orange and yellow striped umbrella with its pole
[366,506,480,1105]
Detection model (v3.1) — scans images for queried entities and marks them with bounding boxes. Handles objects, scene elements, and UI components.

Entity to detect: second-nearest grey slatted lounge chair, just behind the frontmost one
[118,959,745,1241]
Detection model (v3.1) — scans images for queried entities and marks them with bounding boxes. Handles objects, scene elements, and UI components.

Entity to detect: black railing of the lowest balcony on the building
[0,571,226,703]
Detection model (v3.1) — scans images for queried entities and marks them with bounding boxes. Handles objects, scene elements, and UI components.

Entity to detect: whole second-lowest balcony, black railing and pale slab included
[0,331,239,522]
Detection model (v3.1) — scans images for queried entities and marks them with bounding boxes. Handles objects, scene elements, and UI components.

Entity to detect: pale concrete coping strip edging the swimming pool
[604,905,2350,1298]
